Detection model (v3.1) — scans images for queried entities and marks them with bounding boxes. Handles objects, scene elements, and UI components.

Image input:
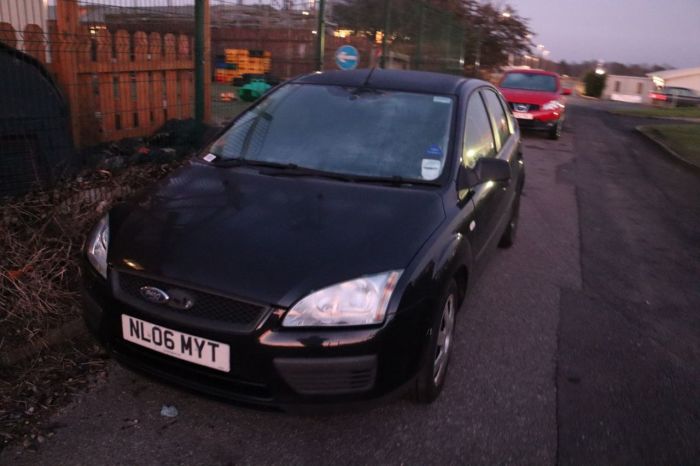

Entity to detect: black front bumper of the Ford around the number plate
[83,267,430,408]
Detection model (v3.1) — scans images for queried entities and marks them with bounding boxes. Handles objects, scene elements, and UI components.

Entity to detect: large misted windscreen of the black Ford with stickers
[210,84,454,180]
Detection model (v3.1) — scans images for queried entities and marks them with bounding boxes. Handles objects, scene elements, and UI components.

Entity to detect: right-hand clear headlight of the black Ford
[282,270,402,327]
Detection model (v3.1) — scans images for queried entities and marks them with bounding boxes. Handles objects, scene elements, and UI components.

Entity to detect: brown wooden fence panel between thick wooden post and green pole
[67,29,194,143]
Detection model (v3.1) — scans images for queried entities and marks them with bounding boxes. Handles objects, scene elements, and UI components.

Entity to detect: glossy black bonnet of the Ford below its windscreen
[109,164,445,307]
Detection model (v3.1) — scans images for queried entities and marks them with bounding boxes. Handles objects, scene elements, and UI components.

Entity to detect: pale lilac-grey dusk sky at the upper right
[506,0,700,68]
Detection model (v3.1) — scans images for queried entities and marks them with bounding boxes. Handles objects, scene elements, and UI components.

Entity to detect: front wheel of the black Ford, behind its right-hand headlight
[413,280,460,404]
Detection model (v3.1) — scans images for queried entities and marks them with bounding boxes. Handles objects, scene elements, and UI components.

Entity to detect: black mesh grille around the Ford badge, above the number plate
[117,272,266,329]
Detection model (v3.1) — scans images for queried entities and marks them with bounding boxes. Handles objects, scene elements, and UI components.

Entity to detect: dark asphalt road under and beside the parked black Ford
[0,99,700,465]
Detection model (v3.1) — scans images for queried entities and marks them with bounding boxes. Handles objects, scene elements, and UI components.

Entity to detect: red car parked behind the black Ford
[498,70,566,139]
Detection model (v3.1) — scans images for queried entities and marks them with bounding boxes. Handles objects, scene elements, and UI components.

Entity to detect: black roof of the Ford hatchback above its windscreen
[292,68,476,95]
